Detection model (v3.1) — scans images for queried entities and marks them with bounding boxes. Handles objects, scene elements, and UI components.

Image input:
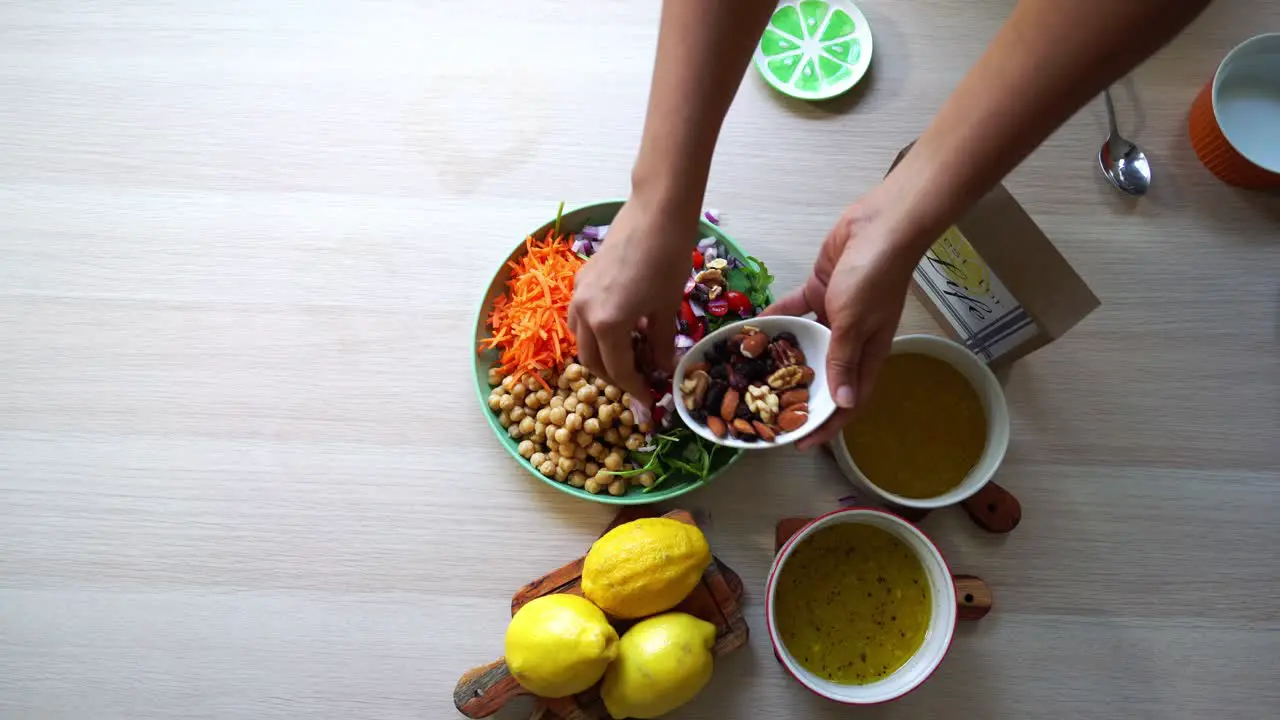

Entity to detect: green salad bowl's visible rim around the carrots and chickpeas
[471,200,773,505]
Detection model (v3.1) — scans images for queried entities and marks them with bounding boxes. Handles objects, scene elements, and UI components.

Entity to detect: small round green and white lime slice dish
[755,0,872,100]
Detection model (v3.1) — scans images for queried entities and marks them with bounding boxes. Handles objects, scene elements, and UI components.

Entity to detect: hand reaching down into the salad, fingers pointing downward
[568,196,698,405]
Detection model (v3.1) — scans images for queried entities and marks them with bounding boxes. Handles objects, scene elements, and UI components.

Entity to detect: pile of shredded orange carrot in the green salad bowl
[480,233,582,389]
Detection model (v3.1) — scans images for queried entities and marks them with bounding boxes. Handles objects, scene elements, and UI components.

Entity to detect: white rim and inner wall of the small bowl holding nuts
[672,315,836,450]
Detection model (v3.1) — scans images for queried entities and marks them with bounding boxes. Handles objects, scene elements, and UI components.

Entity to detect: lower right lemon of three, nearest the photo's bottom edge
[600,612,716,720]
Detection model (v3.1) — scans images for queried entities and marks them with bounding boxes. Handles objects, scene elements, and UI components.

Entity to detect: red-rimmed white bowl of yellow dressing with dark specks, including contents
[764,507,956,705]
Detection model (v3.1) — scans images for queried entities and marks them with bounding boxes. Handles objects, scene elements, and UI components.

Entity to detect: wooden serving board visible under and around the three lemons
[453,507,749,720]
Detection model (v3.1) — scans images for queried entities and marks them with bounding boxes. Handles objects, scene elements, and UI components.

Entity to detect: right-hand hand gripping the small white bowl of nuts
[764,194,919,450]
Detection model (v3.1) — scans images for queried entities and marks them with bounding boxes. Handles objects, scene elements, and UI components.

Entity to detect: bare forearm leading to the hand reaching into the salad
[632,0,776,235]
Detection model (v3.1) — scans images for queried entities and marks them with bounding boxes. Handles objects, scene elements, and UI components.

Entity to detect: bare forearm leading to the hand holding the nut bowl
[876,0,1208,254]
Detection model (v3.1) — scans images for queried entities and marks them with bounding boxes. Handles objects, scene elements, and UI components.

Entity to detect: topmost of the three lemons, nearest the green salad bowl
[582,518,712,619]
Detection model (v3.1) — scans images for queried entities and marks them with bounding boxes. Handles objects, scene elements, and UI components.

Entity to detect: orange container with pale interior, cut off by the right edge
[1187,33,1280,190]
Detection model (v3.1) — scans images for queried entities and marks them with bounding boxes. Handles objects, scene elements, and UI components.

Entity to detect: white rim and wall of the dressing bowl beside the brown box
[831,334,1009,510]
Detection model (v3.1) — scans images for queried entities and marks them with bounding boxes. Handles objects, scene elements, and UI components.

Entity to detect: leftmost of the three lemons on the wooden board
[507,594,618,697]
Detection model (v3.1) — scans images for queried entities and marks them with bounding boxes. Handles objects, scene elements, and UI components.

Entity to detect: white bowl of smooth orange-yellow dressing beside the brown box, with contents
[831,334,1009,509]
